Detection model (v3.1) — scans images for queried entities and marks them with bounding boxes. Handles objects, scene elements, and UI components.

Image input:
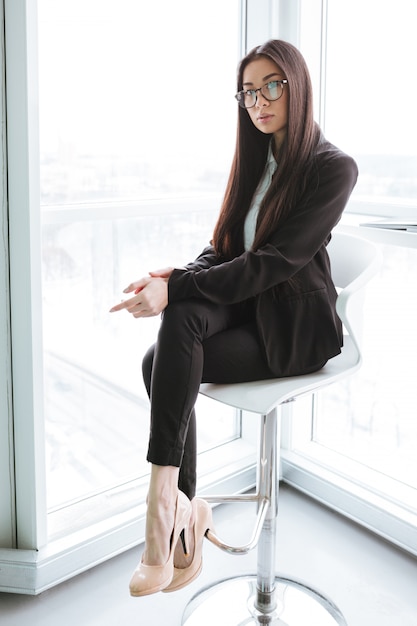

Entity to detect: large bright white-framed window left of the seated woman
[0,0,254,593]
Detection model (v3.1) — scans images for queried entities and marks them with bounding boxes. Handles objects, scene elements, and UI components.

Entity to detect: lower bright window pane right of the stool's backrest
[314,241,417,510]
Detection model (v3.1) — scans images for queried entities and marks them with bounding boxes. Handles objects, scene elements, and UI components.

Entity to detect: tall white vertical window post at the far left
[5,0,46,550]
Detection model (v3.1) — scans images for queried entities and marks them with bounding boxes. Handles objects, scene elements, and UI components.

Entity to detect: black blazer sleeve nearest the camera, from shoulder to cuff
[168,149,358,304]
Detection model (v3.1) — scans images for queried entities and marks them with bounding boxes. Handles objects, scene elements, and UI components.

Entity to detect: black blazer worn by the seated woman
[168,138,358,376]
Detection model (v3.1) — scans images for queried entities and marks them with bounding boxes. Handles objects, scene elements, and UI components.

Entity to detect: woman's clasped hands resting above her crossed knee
[110,267,174,317]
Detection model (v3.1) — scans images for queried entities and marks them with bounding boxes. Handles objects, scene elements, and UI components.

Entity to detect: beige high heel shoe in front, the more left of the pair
[129,491,192,597]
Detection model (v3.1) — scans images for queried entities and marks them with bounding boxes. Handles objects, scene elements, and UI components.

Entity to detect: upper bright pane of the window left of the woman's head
[39,0,238,205]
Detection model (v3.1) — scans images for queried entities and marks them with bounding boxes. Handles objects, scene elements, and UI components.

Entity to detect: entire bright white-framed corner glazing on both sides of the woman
[0,0,417,593]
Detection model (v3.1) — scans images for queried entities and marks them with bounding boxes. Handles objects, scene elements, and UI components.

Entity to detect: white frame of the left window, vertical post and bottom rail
[0,0,270,594]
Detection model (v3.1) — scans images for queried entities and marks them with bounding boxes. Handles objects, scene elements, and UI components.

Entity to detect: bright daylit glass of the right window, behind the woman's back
[296,0,417,511]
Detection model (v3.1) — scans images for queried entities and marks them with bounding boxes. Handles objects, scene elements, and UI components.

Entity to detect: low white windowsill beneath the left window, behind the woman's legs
[0,439,256,595]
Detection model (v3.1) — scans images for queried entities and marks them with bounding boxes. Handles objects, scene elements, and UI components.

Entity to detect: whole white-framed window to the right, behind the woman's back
[284,0,417,553]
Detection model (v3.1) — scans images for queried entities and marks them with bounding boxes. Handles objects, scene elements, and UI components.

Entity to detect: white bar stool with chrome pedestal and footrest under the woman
[182,232,381,626]
